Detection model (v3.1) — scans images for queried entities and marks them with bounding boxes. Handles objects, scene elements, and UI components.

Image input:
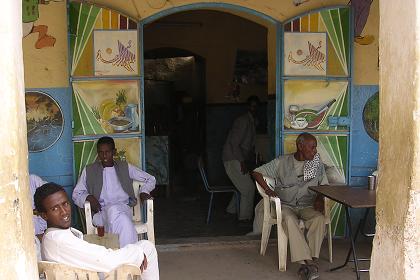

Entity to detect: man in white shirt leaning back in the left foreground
[34,180,159,280]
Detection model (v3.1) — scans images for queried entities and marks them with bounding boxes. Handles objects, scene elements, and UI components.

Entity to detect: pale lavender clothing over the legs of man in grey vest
[93,204,138,248]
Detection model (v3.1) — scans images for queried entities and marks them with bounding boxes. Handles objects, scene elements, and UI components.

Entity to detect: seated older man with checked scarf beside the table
[252,133,328,280]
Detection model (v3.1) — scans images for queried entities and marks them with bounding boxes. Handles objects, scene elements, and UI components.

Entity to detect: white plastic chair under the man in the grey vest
[85,181,155,244]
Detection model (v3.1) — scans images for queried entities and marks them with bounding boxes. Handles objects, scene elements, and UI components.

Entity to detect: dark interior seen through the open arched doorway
[141,5,278,239]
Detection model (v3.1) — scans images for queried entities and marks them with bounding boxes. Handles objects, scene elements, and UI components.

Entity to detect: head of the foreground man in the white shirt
[34,183,71,229]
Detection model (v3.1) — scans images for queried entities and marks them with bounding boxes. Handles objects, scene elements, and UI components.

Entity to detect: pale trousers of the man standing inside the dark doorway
[223,160,256,220]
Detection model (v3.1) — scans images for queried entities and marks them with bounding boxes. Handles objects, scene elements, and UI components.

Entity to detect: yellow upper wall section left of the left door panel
[22,0,69,88]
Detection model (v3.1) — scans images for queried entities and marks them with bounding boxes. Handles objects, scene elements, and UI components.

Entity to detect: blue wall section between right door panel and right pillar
[350,85,379,185]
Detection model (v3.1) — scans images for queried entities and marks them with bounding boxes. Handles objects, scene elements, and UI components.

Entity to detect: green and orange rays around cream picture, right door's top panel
[284,8,350,76]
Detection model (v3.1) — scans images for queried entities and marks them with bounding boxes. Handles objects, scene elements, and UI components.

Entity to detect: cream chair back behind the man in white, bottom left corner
[38,261,141,280]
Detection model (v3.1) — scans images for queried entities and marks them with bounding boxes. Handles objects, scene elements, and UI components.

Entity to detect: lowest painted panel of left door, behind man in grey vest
[74,138,142,177]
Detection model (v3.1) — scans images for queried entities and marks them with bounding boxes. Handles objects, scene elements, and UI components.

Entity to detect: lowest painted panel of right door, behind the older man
[284,135,348,236]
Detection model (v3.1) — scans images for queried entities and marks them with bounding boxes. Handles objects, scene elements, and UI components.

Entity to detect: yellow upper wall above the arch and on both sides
[23,0,379,89]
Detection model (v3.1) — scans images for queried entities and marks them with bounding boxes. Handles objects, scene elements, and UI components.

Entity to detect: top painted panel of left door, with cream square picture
[69,2,138,76]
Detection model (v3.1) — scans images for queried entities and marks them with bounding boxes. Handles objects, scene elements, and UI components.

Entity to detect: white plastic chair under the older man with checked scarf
[256,176,332,271]
